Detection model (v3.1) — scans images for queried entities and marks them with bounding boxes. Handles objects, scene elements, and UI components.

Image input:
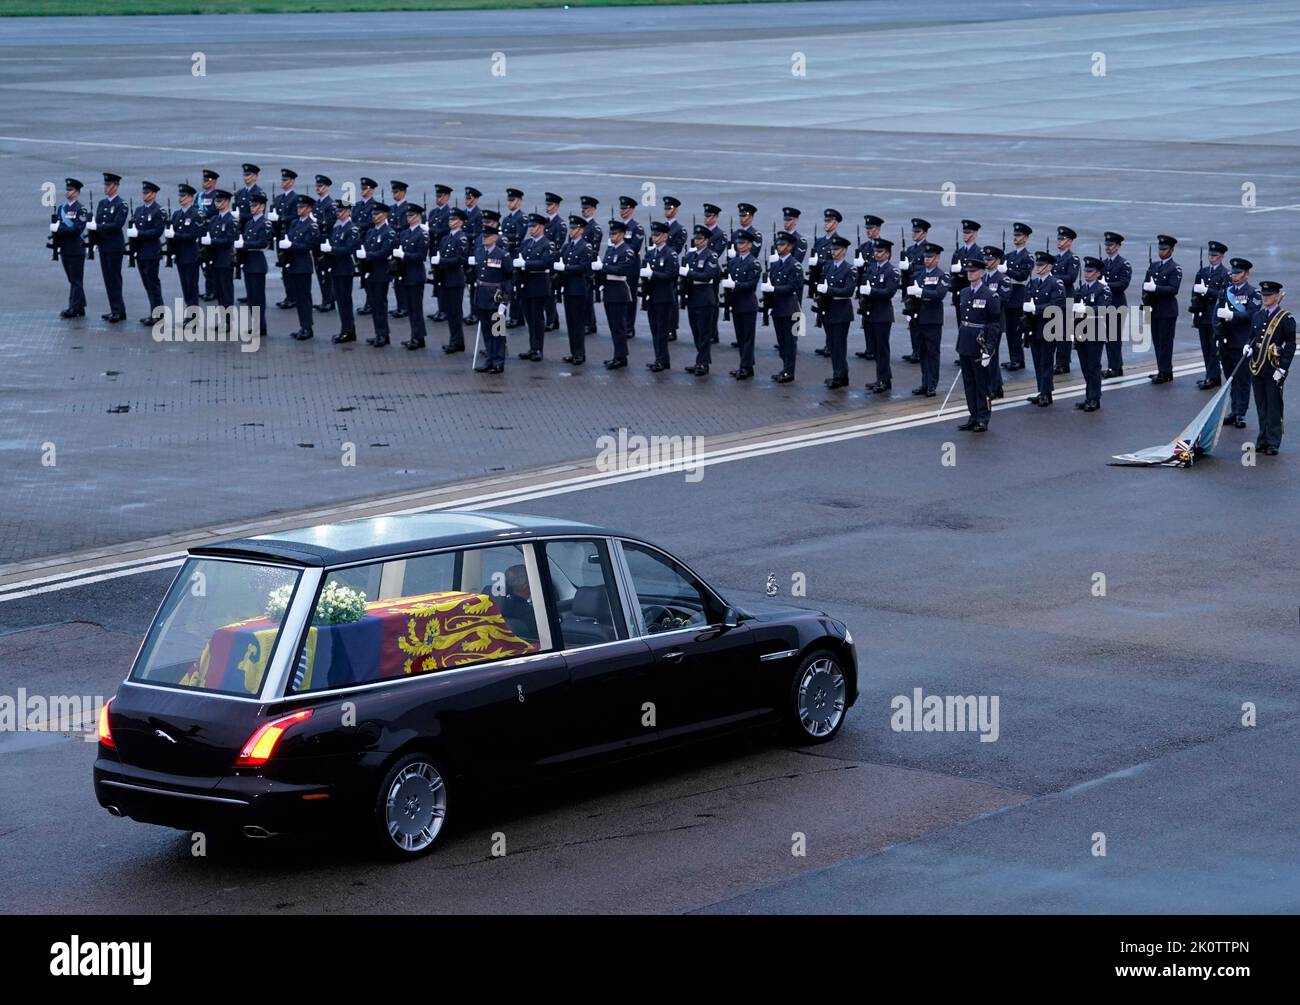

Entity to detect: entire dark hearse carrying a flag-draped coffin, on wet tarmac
[95,512,858,858]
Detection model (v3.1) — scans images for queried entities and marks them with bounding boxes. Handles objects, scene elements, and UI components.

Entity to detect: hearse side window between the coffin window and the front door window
[545,541,628,649]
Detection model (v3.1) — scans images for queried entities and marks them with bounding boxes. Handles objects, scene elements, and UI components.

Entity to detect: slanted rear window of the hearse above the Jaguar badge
[130,558,299,694]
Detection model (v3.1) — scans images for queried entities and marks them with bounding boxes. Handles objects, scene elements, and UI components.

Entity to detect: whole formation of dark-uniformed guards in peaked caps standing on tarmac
[48,170,1296,455]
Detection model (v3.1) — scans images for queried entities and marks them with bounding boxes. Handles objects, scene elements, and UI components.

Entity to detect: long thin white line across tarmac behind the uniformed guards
[0,135,1242,209]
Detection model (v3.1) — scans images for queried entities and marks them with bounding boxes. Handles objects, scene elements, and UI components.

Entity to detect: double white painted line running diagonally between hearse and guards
[0,363,1203,603]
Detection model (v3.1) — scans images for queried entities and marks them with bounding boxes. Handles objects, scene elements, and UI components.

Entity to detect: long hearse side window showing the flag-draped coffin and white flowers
[289,545,542,692]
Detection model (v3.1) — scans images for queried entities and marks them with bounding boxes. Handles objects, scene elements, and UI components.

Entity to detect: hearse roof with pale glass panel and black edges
[190,512,625,566]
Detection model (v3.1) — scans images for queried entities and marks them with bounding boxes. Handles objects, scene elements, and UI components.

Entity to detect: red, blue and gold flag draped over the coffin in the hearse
[181,590,537,694]
